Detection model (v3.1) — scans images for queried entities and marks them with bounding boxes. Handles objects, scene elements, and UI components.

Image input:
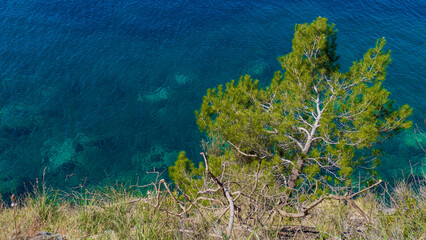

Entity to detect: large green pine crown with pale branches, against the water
[190,17,412,193]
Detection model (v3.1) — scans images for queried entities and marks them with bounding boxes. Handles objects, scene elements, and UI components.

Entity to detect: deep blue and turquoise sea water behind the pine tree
[0,0,426,194]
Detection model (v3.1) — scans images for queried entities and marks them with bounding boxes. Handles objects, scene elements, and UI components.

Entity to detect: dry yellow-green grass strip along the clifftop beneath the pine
[0,174,426,239]
